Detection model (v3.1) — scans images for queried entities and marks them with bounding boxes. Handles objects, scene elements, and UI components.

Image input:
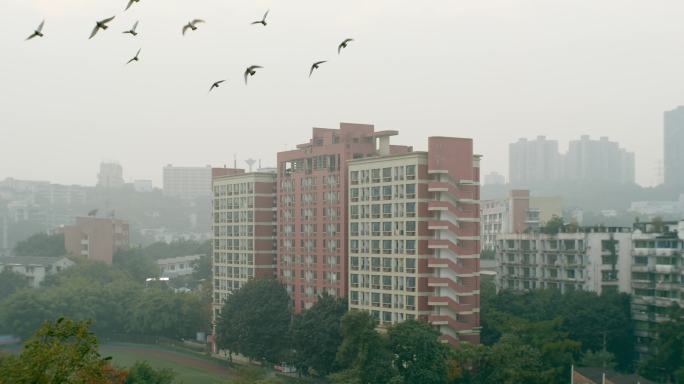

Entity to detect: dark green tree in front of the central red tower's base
[290,295,347,376]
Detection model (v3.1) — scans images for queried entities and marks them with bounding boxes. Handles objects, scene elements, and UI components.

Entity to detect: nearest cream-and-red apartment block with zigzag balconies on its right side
[348,137,480,344]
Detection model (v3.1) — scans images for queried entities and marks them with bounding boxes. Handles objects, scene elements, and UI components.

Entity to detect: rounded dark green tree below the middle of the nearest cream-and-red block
[388,320,448,384]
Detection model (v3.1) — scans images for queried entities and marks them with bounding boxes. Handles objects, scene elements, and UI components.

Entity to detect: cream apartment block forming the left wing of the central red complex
[212,168,277,322]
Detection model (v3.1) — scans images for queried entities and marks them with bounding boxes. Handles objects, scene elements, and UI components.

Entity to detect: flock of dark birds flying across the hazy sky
[26,0,354,92]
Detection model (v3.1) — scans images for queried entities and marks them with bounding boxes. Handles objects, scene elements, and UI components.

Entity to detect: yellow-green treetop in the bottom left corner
[0,318,122,384]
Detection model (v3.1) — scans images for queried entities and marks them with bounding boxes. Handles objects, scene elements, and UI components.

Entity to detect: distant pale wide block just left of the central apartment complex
[163,164,212,200]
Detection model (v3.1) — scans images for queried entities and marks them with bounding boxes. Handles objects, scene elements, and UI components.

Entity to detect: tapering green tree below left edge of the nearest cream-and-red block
[329,311,402,384]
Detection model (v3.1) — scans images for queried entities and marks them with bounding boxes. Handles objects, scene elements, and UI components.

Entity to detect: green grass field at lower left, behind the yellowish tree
[100,343,235,384]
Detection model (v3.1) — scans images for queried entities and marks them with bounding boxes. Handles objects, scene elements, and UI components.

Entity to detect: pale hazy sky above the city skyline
[0,0,684,185]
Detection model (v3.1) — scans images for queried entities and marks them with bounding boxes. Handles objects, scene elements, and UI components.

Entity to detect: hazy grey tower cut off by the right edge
[663,106,684,192]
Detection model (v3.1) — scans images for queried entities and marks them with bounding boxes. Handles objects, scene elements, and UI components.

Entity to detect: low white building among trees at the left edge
[0,256,74,288]
